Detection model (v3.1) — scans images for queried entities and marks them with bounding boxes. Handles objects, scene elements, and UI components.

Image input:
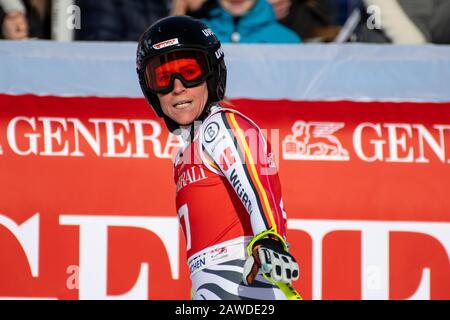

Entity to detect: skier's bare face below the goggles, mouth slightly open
[158,79,208,125]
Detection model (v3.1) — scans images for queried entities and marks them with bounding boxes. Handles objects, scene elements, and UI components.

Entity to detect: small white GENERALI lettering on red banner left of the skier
[0,116,182,158]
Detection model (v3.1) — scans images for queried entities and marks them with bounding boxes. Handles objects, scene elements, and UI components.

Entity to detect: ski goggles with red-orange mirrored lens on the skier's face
[145,50,212,94]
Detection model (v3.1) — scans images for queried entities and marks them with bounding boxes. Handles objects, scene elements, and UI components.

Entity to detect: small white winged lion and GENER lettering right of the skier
[282,120,450,163]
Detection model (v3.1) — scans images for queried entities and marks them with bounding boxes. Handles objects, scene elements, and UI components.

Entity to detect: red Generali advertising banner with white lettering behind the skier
[0,95,450,299]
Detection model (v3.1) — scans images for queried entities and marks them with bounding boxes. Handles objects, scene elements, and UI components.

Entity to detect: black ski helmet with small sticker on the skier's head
[136,16,227,132]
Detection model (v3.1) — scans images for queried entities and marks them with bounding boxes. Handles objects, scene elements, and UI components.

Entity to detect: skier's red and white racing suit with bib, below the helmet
[174,105,286,300]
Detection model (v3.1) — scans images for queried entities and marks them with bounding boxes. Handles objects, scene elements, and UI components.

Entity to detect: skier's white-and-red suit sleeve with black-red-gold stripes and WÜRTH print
[200,111,286,238]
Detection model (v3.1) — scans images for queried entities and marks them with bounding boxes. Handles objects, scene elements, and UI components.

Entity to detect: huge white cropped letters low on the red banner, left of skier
[0,213,180,300]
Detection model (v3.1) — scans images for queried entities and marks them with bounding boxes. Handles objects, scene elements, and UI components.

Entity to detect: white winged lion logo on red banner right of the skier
[283,120,350,161]
